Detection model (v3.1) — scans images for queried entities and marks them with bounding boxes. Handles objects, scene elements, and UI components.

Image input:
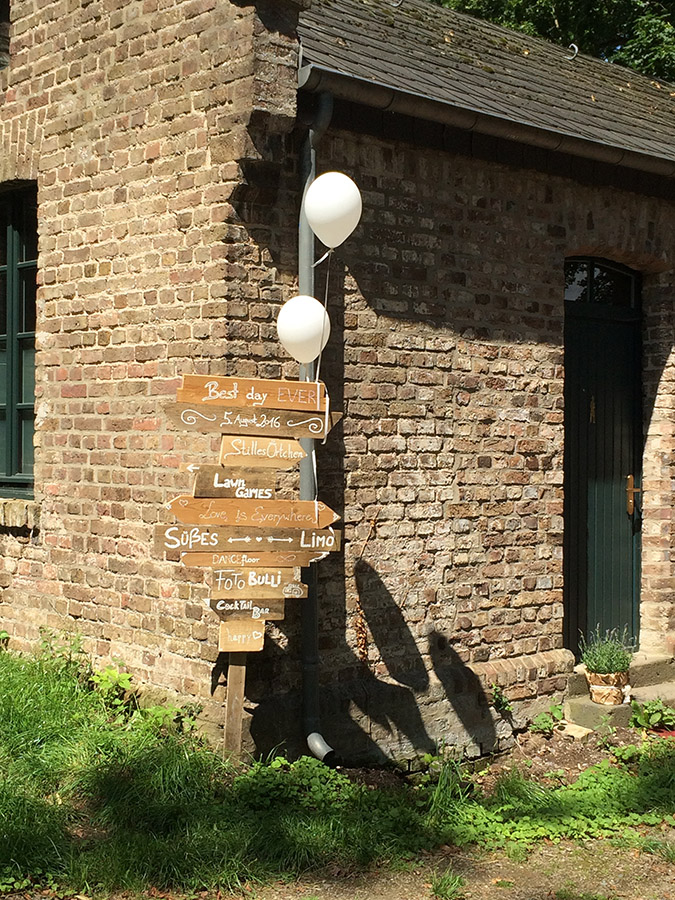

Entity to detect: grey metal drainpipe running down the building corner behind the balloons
[298,92,338,765]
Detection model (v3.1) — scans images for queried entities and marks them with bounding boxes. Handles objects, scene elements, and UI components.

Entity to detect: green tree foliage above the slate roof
[436,0,675,82]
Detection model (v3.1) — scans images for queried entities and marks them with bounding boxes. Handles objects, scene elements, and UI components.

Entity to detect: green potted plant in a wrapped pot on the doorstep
[579,625,634,706]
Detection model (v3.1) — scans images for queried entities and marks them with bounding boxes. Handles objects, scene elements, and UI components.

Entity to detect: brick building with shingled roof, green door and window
[0,0,675,758]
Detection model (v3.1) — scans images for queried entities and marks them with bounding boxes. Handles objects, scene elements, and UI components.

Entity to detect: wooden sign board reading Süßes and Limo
[155,524,342,552]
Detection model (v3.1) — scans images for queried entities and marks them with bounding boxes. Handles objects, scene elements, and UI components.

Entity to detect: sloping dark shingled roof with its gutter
[298,0,675,175]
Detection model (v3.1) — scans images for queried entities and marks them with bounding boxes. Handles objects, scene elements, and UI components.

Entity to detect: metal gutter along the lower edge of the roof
[298,63,675,178]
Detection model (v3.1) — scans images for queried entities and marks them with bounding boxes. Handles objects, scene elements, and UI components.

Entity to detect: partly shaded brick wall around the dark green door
[252,129,675,756]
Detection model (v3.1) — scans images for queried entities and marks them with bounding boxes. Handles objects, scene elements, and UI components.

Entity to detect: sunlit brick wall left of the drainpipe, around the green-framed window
[0,0,299,732]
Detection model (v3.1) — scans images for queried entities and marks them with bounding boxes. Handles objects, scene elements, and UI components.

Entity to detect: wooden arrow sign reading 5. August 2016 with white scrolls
[164,403,342,438]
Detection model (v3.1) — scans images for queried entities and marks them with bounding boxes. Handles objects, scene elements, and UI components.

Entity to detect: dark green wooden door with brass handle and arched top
[564,259,641,652]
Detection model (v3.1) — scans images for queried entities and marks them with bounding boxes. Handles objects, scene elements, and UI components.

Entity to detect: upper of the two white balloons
[304,172,362,247]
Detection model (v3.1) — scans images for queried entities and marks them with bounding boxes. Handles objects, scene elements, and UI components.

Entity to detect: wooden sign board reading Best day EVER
[176,375,326,412]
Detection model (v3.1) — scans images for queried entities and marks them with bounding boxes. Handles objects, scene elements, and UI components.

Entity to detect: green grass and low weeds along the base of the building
[0,651,675,897]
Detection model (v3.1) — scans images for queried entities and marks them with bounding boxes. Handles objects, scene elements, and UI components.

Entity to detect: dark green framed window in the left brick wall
[0,188,37,498]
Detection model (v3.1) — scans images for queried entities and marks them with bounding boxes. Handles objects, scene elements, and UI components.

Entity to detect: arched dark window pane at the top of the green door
[565,259,638,309]
